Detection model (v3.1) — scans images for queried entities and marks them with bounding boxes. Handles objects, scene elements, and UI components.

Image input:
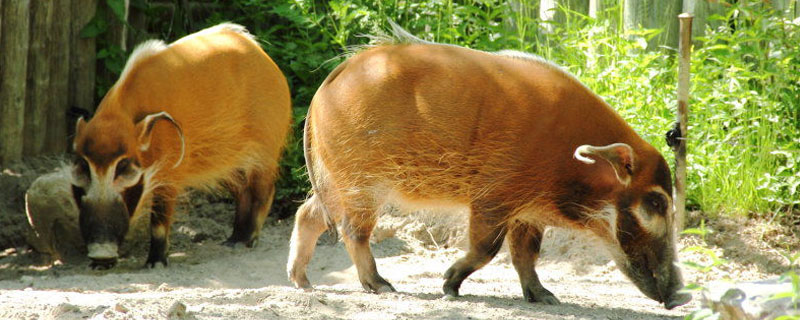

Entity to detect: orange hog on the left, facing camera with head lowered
[72,23,291,268]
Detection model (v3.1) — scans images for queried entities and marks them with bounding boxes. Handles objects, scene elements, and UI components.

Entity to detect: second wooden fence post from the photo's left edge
[22,1,55,156]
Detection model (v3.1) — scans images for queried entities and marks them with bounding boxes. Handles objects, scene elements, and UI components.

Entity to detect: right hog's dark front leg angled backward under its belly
[442,204,508,297]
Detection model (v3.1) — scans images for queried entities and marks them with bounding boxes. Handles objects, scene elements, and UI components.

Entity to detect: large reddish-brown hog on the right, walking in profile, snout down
[287,26,691,309]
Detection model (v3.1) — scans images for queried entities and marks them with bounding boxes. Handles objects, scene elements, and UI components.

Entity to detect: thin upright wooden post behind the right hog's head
[673,13,693,232]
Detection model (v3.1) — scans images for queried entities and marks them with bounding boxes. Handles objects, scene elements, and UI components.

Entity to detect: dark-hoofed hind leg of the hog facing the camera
[225,171,275,248]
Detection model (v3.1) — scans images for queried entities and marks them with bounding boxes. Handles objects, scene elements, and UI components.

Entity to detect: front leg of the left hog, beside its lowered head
[145,188,177,268]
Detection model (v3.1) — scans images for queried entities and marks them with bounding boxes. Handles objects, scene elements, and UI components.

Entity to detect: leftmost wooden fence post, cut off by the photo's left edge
[0,0,30,164]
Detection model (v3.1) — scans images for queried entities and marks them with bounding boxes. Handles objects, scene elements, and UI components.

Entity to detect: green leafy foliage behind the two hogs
[84,0,800,224]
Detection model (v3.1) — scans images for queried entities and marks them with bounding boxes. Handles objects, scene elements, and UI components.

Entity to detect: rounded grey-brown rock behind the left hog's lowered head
[25,166,150,264]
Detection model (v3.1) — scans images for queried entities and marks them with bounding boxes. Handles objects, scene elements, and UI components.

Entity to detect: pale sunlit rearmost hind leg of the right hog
[286,195,328,289]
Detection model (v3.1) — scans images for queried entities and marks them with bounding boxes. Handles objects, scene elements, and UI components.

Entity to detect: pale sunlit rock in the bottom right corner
[702,279,800,319]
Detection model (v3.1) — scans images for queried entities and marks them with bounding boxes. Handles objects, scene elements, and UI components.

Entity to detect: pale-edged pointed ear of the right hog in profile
[574,143,634,187]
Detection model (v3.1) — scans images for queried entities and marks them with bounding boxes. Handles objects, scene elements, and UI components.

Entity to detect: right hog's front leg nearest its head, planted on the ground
[507,222,560,304]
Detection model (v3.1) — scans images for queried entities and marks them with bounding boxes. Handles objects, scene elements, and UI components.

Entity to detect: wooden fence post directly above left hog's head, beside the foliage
[67,0,97,136]
